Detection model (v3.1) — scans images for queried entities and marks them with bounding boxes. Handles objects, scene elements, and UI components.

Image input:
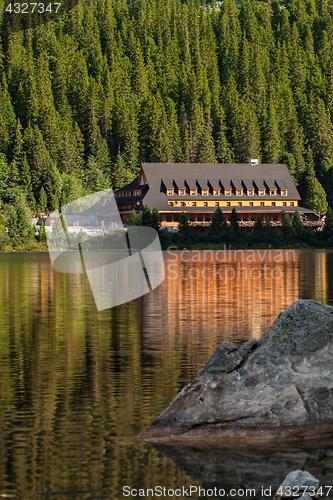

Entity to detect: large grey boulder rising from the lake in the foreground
[140,300,333,444]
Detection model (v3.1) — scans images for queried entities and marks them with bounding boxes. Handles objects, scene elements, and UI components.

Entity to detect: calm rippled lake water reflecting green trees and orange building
[0,250,333,500]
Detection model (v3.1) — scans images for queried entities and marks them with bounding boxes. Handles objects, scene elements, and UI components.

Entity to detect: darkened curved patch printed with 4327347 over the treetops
[3,0,78,31]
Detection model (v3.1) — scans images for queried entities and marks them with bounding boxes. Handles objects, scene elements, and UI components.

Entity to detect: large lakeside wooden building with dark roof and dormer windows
[115,160,321,230]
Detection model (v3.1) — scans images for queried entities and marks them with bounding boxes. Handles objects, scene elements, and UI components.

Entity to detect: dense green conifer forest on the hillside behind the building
[0,0,333,213]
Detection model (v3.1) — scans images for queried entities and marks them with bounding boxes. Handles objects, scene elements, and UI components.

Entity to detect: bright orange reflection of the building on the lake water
[142,250,299,349]
